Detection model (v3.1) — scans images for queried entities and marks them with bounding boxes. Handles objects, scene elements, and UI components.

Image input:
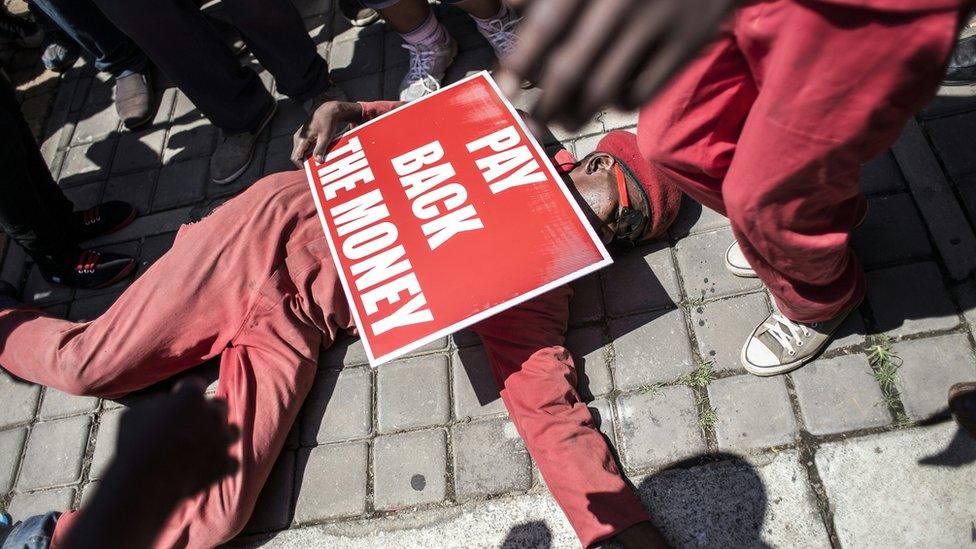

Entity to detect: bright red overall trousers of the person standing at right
[638,0,962,322]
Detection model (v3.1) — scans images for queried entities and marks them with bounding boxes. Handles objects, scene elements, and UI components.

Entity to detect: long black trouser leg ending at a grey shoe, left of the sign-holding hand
[95,0,270,132]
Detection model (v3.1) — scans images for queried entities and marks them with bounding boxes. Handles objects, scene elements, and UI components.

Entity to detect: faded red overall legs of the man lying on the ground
[0,172,332,547]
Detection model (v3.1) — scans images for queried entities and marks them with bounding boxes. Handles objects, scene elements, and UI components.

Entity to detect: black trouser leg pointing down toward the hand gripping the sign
[224,0,331,99]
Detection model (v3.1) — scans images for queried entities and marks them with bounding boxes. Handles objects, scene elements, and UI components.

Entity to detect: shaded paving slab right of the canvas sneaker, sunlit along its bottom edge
[868,263,959,336]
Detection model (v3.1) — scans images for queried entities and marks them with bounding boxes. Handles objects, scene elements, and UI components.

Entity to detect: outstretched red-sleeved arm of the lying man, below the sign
[472,287,648,547]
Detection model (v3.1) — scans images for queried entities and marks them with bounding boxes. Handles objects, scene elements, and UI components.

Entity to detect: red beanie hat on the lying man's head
[596,130,681,240]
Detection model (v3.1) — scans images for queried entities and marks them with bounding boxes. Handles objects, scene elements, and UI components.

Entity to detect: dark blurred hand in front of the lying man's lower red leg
[106,379,240,500]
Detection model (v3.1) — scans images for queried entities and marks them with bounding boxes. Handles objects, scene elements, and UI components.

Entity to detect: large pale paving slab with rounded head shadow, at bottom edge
[638,452,830,548]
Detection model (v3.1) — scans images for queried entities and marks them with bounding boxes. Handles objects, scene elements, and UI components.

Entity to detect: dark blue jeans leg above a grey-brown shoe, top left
[33,0,146,76]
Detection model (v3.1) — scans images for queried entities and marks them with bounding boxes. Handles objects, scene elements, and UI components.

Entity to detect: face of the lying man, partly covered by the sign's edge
[567,153,650,244]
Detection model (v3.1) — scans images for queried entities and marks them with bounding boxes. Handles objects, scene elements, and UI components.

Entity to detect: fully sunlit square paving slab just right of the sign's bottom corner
[376,355,451,433]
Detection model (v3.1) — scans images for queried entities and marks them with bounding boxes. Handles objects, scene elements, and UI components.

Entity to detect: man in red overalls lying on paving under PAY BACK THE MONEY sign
[0,102,679,547]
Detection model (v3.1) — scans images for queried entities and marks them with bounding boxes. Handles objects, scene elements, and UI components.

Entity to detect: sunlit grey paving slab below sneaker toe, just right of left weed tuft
[708,374,797,452]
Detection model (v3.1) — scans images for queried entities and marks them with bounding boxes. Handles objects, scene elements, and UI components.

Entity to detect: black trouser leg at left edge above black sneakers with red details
[0,76,78,268]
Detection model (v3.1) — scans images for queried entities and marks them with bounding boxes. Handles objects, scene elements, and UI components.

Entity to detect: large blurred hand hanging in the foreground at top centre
[499,0,736,129]
